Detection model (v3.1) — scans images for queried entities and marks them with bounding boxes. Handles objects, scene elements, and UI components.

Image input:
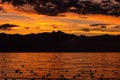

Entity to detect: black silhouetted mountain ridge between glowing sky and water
[0,31,120,52]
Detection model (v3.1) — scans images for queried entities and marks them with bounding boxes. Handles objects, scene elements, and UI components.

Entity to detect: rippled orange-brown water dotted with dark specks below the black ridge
[0,53,120,80]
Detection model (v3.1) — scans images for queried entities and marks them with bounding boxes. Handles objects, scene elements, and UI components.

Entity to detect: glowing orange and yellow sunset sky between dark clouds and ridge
[0,0,120,35]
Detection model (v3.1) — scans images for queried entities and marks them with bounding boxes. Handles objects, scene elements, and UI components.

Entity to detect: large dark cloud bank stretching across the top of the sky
[1,0,120,16]
